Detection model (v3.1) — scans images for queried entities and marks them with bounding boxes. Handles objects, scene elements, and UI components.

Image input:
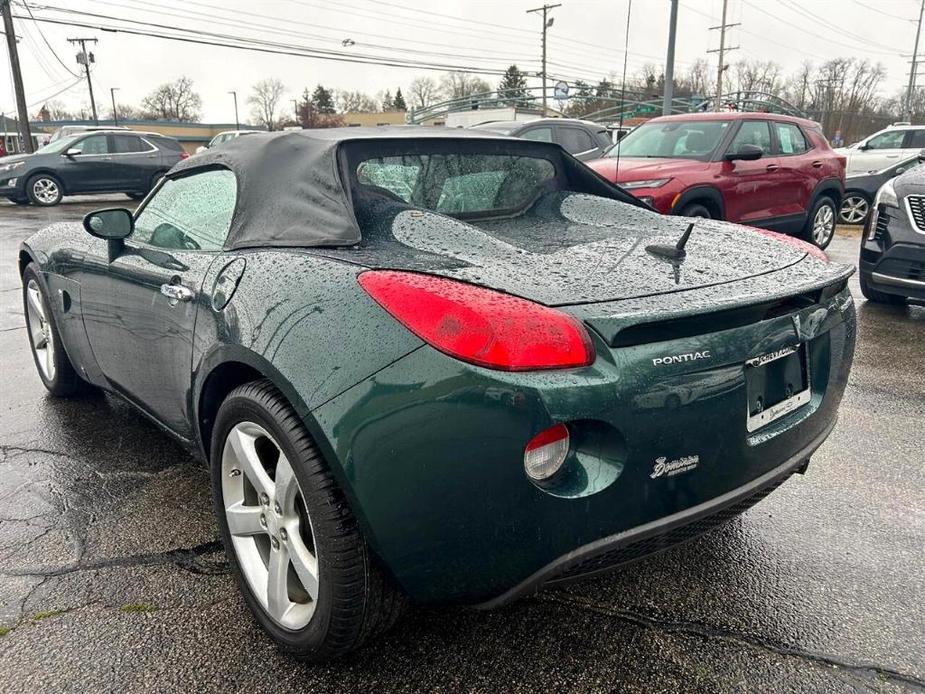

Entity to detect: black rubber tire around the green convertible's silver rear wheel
[210,380,407,662]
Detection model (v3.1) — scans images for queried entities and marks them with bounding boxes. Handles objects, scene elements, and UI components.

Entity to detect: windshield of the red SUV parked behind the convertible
[606,120,731,161]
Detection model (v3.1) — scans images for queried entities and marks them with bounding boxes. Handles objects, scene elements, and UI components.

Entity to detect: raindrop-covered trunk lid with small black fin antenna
[334,194,821,306]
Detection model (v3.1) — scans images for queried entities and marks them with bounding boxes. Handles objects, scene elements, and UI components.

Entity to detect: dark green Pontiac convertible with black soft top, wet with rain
[19,128,855,660]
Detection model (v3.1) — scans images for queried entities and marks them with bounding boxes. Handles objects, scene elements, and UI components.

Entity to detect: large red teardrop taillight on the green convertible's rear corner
[359,270,594,371]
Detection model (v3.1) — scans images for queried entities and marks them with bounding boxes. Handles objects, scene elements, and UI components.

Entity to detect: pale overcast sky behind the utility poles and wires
[0,0,925,122]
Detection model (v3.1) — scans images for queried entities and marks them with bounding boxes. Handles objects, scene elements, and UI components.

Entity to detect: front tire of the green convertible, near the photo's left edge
[22,263,93,398]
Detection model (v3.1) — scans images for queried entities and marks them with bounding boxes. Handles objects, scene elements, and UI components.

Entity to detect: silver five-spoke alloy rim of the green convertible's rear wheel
[222,422,319,630]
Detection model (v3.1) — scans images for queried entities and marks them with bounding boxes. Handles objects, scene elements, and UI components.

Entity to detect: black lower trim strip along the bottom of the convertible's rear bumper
[476,420,835,610]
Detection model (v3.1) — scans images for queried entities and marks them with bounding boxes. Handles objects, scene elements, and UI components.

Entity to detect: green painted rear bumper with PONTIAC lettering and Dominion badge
[309,289,855,606]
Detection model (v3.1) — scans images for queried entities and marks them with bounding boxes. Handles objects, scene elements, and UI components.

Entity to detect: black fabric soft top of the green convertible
[168,126,640,250]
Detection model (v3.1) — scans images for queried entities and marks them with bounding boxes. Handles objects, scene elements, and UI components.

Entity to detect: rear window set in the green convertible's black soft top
[351,153,556,217]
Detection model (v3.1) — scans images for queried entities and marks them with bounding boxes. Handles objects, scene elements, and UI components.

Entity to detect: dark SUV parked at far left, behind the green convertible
[0,130,189,205]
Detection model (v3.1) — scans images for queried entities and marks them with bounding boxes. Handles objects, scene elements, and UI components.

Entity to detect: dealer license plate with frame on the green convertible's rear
[745,344,810,432]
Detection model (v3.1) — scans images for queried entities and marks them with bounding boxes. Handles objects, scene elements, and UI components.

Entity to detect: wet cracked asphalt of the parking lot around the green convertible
[0,196,925,694]
